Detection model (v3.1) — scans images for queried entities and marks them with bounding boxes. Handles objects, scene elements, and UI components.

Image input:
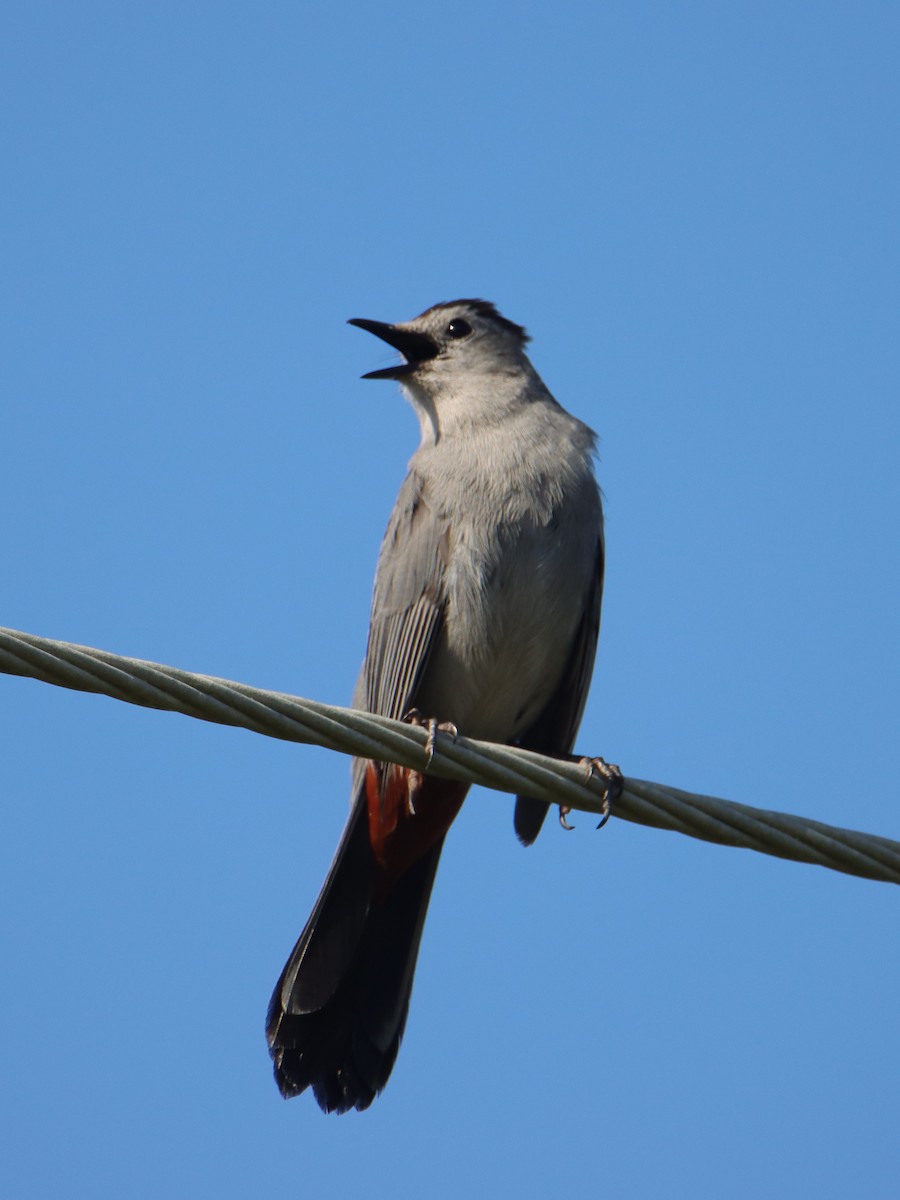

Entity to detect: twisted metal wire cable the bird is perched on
[0,629,900,883]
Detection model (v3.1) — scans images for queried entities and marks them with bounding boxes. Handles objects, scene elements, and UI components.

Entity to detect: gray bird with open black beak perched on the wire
[266,300,616,1112]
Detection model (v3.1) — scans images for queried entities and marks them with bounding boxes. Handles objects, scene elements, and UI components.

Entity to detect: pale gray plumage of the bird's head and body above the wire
[356,300,604,841]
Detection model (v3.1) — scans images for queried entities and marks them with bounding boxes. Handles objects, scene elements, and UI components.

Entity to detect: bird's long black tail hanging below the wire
[265,797,443,1112]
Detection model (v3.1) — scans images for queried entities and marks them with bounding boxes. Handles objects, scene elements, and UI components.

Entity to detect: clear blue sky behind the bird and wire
[0,0,900,1200]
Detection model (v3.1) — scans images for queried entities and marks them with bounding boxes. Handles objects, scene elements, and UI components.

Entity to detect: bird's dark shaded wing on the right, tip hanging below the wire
[515,532,604,846]
